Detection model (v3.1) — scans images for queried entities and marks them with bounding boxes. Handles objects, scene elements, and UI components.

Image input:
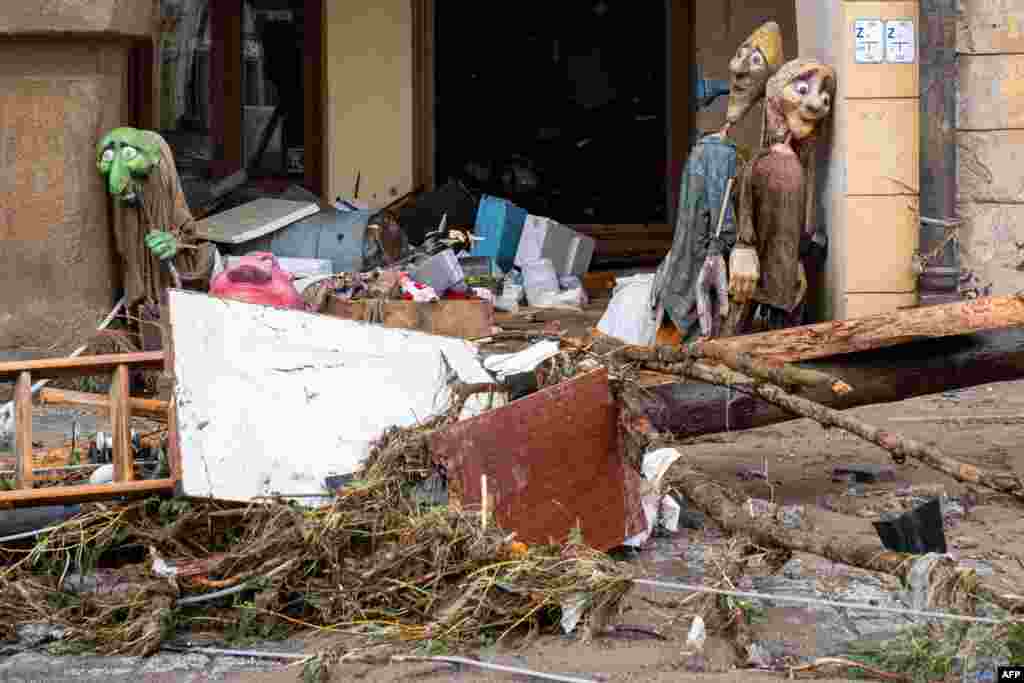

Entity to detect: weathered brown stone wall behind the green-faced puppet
[0,0,155,355]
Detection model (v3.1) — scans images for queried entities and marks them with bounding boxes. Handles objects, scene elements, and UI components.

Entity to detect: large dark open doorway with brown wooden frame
[414,0,694,240]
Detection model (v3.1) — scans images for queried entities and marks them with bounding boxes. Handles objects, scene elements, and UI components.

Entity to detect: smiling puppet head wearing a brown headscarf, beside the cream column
[765,59,837,142]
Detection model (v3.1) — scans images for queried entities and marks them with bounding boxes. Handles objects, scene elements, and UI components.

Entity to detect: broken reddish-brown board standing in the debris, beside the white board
[431,370,644,550]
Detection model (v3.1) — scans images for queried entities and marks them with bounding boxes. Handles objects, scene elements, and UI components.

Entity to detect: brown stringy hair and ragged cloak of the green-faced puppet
[112,131,213,306]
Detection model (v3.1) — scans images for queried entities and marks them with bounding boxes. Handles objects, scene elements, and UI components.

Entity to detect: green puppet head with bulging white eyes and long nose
[96,128,160,206]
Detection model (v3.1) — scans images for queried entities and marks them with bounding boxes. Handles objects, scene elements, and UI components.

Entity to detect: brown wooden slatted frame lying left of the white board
[0,352,181,508]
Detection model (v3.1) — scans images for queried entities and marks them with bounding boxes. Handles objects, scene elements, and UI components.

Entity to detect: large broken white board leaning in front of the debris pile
[170,290,494,501]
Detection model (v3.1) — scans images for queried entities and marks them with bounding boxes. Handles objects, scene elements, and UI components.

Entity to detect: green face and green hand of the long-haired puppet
[96,128,178,260]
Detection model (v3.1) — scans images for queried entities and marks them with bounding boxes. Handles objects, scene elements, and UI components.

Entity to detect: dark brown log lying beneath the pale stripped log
[631,330,1024,438]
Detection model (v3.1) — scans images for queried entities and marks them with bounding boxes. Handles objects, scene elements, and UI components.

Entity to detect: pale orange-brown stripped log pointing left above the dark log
[708,296,1024,362]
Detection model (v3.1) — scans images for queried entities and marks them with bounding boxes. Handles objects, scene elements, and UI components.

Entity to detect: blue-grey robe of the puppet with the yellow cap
[651,135,737,339]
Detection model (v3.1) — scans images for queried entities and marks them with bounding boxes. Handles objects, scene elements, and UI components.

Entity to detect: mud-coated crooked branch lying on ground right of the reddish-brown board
[672,460,1024,612]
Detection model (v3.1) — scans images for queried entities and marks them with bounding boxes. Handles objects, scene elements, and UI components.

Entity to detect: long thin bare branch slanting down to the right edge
[663,362,1024,501]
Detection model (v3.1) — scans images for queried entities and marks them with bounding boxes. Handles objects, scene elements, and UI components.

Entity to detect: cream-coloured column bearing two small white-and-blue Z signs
[797,0,921,318]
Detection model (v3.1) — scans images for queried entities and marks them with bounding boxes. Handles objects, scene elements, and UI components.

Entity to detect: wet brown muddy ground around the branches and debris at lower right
[226,382,1024,683]
